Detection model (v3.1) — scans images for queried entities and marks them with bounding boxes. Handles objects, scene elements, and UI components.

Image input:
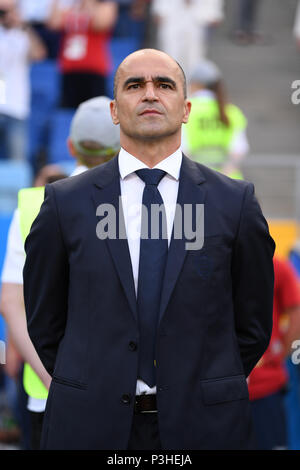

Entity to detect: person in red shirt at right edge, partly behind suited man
[248,256,300,450]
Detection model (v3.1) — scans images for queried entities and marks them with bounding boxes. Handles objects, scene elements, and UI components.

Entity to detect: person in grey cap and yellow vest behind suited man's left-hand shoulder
[0,97,120,449]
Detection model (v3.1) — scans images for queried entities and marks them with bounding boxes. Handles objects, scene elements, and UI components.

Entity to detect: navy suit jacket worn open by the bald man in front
[24,156,274,450]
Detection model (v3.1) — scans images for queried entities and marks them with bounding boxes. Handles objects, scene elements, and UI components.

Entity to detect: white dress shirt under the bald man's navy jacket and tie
[119,148,182,395]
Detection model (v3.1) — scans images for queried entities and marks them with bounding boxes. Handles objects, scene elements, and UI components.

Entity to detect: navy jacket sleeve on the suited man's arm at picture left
[23,185,69,375]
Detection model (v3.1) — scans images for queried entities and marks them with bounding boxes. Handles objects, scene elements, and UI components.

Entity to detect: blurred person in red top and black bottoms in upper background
[47,0,118,108]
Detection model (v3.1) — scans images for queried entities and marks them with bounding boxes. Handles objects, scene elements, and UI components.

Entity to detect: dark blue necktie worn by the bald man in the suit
[136,169,168,387]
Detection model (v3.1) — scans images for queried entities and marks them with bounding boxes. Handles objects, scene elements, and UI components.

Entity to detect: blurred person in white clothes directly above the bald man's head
[152,0,224,78]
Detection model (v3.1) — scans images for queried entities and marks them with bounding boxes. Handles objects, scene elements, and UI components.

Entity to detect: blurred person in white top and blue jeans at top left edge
[0,0,46,160]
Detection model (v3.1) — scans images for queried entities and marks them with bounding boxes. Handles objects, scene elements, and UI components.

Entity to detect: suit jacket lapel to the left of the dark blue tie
[93,157,137,319]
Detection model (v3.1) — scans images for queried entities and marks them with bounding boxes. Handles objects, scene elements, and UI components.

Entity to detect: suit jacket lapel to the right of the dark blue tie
[159,155,205,321]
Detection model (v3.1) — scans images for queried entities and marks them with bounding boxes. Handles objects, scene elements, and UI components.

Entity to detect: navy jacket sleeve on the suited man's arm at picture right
[232,184,275,376]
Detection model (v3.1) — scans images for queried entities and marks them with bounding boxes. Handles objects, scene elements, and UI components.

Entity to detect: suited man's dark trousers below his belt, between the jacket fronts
[128,413,161,450]
